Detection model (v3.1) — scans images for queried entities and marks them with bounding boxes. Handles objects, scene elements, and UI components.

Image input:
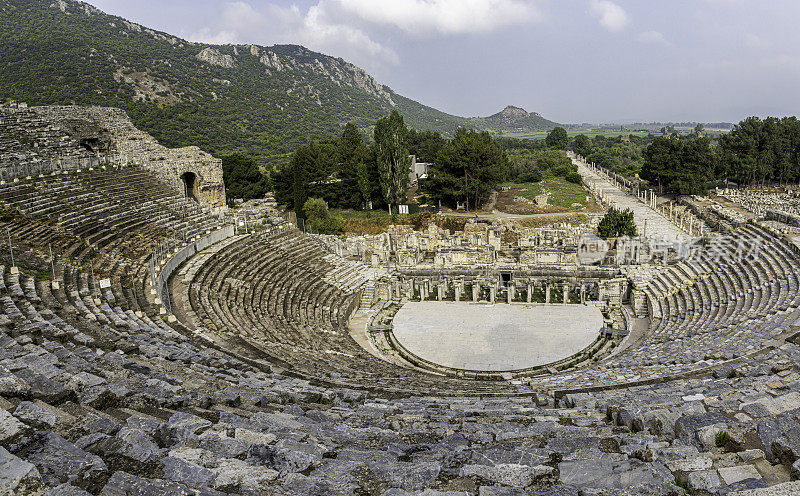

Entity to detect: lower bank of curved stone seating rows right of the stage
[540,224,800,388]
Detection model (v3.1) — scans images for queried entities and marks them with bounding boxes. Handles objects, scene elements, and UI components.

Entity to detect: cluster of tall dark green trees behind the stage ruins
[271,111,509,217]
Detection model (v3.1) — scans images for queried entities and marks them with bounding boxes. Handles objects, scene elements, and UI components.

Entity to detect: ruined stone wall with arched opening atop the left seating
[0,106,225,208]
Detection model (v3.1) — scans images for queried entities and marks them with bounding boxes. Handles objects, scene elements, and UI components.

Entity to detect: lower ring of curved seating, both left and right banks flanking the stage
[183,221,800,396]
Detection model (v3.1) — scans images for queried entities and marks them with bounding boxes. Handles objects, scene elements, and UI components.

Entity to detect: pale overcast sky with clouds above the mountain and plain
[89,0,800,123]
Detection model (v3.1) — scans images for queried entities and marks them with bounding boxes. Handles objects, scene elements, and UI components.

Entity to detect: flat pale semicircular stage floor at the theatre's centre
[393,301,603,372]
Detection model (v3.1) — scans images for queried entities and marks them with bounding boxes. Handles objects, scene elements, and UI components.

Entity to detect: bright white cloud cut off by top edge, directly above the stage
[336,0,542,36]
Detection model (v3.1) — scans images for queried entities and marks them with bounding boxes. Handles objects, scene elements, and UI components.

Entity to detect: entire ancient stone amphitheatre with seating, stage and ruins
[0,107,800,496]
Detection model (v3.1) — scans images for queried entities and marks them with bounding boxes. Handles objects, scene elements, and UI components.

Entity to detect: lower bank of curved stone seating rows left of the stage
[184,228,519,394]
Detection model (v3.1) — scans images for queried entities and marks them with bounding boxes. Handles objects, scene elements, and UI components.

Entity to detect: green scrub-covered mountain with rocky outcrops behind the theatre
[0,0,552,164]
